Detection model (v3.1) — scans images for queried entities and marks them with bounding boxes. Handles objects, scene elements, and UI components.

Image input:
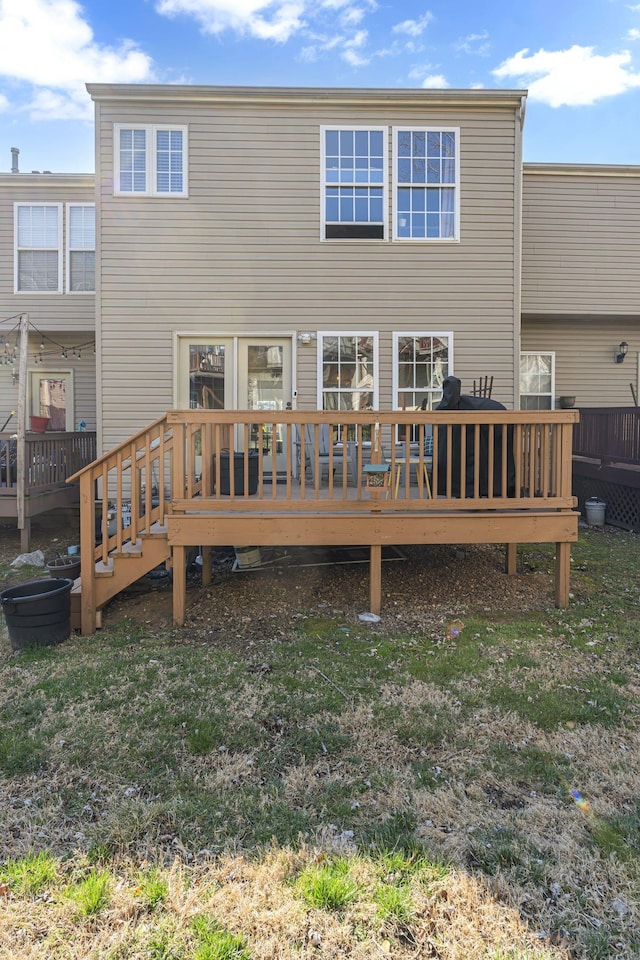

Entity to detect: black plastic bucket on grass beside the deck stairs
[0,577,73,650]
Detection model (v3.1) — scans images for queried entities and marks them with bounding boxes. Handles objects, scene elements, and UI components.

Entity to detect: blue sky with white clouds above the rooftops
[0,0,640,173]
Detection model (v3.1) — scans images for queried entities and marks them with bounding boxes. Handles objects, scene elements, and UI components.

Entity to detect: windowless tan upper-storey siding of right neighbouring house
[522,164,640,317]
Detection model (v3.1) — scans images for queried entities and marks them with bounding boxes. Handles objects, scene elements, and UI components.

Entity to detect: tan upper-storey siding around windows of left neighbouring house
[0,173,95,334]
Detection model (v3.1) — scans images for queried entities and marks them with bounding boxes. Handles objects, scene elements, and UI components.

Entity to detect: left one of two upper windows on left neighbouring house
[14,203,62,293]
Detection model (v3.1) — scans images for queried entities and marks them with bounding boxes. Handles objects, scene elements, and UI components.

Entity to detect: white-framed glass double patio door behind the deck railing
[177,336,292,474]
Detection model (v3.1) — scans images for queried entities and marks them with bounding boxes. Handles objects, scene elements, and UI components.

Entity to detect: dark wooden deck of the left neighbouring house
[0,432,96,551]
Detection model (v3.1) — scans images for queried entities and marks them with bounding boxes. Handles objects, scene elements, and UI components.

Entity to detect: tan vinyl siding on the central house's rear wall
[92,91,520,447]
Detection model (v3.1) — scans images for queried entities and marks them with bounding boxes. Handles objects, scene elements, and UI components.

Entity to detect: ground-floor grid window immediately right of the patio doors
[318,333,378,410]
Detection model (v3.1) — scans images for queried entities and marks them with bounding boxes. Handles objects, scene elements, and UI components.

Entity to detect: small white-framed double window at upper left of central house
[114,123,188,197]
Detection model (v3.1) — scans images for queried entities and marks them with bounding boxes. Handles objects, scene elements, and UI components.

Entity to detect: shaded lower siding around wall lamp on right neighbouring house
[522,317,640,407]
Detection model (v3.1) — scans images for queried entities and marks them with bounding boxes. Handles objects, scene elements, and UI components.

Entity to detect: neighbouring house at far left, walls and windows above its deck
[0,160,96,431]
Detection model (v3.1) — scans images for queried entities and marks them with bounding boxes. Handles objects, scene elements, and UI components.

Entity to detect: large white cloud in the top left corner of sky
[0,0,153,120]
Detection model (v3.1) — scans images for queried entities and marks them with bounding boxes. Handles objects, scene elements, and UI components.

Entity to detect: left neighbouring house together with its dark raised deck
[0,149,96,549]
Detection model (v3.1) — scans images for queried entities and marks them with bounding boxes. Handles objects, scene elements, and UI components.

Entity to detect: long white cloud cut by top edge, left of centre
[156,0,305,43]
